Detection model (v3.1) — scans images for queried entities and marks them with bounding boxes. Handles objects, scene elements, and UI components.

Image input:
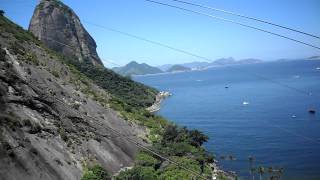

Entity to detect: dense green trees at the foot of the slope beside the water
[116,124,213,180]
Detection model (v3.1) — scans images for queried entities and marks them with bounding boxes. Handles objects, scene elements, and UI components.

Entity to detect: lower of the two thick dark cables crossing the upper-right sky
[145,0,320,50]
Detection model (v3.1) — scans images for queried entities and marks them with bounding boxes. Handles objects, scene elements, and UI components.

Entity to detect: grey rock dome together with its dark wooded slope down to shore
[29,0,158,107]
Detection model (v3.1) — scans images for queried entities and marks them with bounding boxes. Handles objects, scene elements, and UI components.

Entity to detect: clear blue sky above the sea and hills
[0,0,320,67]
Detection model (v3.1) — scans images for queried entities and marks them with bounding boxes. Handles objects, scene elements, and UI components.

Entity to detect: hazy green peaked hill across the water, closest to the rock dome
[112,61,163,76]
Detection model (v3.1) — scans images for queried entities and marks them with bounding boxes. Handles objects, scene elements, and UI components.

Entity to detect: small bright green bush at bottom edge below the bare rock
[81,165,111,180]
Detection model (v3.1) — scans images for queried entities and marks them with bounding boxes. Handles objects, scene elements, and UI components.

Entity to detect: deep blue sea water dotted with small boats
[134,60,320,180]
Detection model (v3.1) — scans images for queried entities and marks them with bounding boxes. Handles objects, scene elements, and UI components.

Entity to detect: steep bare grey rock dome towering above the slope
[29,0,103,66]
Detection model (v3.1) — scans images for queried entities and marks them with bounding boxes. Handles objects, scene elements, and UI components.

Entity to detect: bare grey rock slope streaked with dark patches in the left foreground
[0,17,145,180]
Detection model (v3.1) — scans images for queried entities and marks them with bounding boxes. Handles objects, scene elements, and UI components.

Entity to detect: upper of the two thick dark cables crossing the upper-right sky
[171,0,320,39]
